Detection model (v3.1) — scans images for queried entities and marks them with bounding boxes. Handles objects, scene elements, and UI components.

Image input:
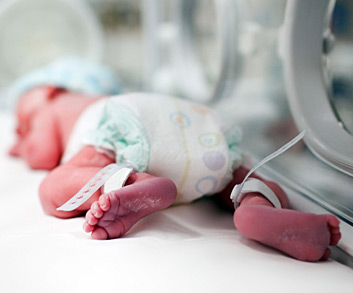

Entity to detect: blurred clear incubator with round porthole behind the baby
[0,0,353,259]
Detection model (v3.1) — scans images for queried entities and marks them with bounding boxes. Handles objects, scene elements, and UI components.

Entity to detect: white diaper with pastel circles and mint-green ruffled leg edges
[70,94,242,203]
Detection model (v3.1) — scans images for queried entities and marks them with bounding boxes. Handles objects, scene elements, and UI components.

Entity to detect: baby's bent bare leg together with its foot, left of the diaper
[39,146,177,239]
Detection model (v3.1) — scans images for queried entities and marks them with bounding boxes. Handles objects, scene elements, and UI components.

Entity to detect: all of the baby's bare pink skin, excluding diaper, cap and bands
[11,87,341,261]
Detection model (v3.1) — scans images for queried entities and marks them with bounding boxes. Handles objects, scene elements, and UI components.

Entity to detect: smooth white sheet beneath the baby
[0,113,353,292]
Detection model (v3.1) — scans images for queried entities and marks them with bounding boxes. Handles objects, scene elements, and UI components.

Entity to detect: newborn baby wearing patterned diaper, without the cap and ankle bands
[11,58,341,261]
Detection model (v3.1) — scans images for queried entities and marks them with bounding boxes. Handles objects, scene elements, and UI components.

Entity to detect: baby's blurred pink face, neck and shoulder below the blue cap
[9,86,99,170]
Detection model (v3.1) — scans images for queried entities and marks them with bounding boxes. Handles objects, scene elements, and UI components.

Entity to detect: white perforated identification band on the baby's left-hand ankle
[56,162,134,212]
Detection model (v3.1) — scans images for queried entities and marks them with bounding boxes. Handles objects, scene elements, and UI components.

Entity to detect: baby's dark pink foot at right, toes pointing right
[234,206,341,261]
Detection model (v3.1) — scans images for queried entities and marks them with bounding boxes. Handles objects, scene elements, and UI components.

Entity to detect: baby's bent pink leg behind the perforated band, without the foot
[39,146,114,218]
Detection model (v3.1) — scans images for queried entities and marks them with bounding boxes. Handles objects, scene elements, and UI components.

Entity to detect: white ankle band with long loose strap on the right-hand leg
[230,130,306,208]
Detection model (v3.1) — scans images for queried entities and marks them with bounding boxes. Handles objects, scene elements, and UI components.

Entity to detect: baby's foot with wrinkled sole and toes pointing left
[83,177,176,240]
